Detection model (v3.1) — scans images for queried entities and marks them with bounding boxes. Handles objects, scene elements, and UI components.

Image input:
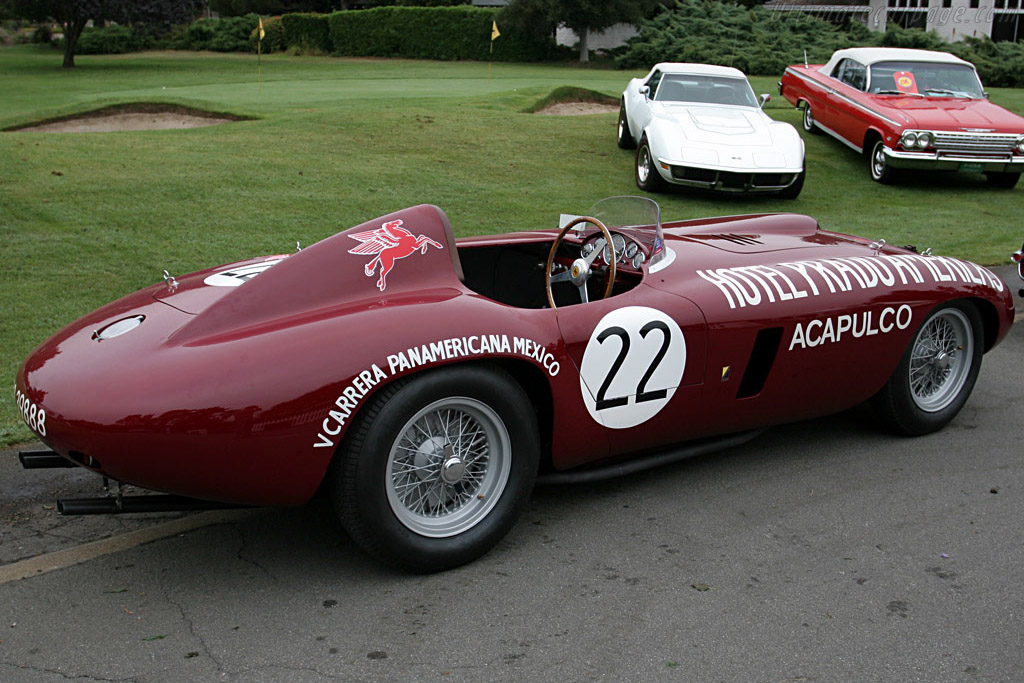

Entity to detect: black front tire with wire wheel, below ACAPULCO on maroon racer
[871,301,984,436]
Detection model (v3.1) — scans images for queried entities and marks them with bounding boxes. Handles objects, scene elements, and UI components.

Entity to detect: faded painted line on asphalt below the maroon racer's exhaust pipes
[0,510,252,585]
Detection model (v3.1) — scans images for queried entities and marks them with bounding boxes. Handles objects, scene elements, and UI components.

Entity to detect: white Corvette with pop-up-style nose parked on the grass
[618,62,805,199]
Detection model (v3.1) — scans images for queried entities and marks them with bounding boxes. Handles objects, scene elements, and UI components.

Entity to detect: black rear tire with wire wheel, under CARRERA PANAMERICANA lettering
[328,366,540,573]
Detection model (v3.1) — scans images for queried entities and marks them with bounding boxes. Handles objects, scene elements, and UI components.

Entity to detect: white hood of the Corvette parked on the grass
[662,103,772,146]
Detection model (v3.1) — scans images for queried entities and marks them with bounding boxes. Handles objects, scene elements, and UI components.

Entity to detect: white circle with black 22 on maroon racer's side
[580,306,686,429]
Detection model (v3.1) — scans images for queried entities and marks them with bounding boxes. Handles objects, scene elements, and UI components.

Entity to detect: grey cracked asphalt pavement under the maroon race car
[0,268,1024,683]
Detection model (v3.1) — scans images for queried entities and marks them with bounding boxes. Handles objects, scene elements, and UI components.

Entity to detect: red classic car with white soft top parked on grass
[778,47,1024,188]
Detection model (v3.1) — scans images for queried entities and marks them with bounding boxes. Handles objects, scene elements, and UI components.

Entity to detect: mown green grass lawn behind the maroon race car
[0,47,1024,443]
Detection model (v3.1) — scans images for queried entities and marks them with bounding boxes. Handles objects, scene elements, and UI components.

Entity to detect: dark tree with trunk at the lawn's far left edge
[10,0,203,68]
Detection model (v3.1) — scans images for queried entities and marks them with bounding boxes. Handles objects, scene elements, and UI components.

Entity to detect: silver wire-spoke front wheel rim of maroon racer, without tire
[909,308,974,413]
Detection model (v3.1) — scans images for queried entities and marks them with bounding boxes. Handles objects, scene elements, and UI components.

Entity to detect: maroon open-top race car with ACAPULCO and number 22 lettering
[15,198,1014,571]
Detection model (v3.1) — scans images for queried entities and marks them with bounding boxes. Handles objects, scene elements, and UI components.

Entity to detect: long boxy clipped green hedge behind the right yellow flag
[328,6,554,61]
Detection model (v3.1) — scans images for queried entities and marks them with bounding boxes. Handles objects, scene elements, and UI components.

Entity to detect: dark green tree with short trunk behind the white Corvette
[509,0,659,62]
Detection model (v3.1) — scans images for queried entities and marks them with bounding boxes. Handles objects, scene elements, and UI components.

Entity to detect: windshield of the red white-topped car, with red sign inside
[869,61,985,98]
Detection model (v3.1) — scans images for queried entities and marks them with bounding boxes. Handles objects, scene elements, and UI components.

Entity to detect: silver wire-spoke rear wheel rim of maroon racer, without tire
[386,397,511,538]
